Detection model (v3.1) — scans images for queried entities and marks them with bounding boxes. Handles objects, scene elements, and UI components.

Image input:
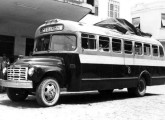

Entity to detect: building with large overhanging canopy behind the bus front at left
[0,0,92,59]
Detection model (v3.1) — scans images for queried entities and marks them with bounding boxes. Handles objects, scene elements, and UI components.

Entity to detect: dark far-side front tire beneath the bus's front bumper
[7,88,28,102]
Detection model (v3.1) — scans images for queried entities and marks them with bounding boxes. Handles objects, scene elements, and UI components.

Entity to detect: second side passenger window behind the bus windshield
[99,36,109,52]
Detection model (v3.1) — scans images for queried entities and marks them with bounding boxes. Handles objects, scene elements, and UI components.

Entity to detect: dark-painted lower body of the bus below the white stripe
[30,53,165,91]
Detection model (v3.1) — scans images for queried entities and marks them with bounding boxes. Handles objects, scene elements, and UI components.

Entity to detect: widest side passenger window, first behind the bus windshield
[81,33,96,50]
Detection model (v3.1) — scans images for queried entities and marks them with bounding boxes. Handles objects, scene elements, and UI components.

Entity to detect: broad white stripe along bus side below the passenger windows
[79,54,165,66]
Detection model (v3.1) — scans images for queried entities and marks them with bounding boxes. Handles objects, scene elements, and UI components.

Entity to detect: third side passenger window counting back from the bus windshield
[112,38,121,53]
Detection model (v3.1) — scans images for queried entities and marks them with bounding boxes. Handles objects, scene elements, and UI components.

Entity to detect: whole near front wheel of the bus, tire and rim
[36,78,60,107]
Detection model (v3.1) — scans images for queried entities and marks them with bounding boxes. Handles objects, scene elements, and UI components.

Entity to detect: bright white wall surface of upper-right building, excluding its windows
[132,3,165,40]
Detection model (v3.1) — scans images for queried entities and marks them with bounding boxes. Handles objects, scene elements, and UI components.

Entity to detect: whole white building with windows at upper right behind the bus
[131,1,165,48]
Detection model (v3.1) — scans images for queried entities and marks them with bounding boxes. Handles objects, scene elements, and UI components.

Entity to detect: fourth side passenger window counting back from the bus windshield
[124,41,132,54]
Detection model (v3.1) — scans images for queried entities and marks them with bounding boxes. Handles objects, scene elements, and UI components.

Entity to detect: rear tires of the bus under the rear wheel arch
[128,78,146,97]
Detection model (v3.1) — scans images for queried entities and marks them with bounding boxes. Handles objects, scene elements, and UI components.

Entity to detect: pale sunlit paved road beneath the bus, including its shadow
[0,85,165,120]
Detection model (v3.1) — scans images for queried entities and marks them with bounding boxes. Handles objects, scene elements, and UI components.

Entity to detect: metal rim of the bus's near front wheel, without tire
[43,82,59,104]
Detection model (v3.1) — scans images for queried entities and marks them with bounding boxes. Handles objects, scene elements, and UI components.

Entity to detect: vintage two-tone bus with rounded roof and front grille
[0,19,165,106]
